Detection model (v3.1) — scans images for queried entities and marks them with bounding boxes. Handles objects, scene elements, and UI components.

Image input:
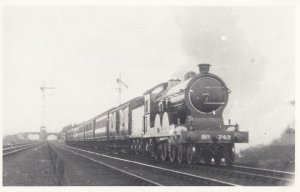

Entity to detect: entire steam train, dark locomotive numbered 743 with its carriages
[65,64,248,166]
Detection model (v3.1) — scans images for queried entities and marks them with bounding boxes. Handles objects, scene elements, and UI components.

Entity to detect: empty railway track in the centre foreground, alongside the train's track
[54,144,238,186]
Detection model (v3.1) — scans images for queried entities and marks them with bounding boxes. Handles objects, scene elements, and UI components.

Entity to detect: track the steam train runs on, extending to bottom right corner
[60,142,295,186]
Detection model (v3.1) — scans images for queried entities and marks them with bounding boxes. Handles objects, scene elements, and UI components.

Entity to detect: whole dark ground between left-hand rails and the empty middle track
[2,143,134,186]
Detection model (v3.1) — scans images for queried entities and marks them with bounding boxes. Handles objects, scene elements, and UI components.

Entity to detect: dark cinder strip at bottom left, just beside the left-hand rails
[2,144,56,186]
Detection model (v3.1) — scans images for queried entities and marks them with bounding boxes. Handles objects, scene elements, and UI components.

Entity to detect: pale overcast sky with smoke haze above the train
[3,6,295,147]
